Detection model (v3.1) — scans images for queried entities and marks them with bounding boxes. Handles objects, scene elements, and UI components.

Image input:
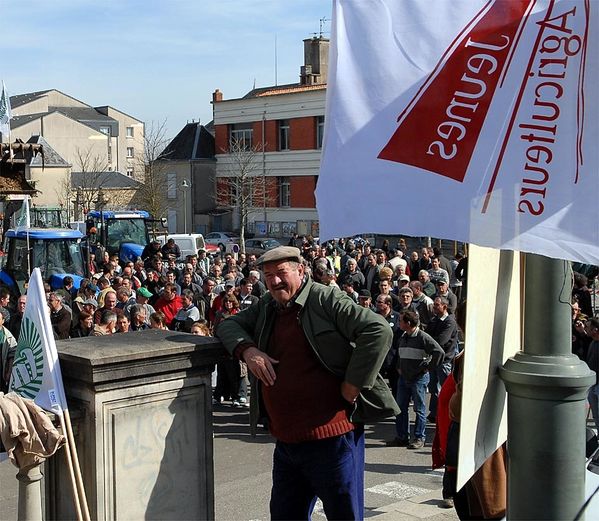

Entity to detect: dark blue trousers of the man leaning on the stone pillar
[270,426,364,520]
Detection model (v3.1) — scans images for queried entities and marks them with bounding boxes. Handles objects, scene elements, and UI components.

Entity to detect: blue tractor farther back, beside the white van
[86,210,164,262]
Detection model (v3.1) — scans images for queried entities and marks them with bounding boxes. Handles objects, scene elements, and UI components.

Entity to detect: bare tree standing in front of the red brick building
[215,139,268,252]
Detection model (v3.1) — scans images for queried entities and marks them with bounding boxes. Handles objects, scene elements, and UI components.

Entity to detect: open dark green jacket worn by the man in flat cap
[216,279,399,432]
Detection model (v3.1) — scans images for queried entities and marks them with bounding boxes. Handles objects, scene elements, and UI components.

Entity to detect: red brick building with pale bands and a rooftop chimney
[212,37,329,237]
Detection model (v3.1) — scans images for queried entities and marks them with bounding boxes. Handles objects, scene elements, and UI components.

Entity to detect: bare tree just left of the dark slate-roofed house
[136,120,169,219]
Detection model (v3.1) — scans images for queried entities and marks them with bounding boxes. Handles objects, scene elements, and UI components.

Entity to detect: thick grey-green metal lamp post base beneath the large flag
[500,254,595,520]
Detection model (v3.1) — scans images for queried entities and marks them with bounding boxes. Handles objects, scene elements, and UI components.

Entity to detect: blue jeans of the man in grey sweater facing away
[395,373,430,440]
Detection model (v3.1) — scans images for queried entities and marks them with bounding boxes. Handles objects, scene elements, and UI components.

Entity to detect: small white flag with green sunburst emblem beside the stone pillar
[9,268,67,414]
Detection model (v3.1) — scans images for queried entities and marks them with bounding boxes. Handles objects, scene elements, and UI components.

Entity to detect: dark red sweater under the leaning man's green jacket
[262,304,354,443]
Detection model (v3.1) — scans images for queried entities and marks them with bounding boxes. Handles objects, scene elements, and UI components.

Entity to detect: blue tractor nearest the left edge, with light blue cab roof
[0,228,88,296]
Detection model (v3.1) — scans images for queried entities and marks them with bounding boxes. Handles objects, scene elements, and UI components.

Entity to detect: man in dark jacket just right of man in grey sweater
[426,297,458,422]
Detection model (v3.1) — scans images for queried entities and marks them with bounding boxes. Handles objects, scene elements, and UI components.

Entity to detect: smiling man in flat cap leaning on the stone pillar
[216,246,398,519]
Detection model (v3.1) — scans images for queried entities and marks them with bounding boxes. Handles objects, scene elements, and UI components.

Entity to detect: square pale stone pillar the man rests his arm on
[46,330,225,520]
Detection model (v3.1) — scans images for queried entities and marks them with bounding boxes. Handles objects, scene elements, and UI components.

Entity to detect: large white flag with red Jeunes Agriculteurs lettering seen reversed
[316,0,599,264]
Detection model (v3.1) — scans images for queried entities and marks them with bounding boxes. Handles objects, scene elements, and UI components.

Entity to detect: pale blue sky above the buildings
[0,0,332,138]
